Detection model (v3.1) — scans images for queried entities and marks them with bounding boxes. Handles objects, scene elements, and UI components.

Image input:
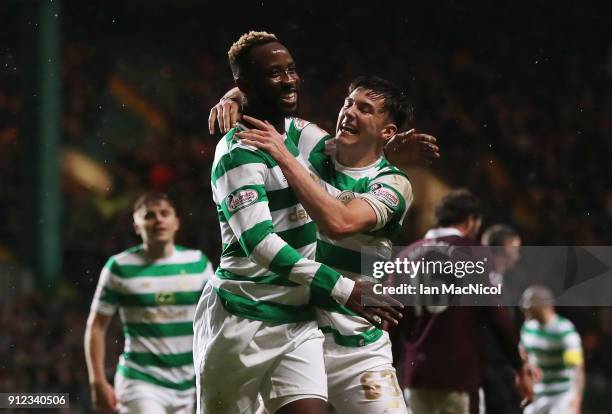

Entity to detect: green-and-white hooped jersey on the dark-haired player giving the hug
[290,124,413,347]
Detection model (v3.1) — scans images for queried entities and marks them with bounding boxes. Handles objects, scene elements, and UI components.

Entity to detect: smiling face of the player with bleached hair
[241,42,300,116]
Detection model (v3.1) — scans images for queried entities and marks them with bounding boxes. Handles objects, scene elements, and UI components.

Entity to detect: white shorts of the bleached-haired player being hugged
[193,284,327,414]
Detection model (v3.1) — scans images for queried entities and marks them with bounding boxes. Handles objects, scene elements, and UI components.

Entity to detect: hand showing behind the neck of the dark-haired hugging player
[385,129,440,165]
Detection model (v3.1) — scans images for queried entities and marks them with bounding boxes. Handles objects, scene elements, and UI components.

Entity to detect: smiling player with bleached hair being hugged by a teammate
[194,32,400,414]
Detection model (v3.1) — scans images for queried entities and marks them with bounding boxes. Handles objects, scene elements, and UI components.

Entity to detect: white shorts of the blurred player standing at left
[115,373,196,414]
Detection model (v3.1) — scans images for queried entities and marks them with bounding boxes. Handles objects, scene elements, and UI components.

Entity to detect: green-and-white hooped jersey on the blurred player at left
[91,246,213,391]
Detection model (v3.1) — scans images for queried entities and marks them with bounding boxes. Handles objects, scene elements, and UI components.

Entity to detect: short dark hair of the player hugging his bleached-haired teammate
[349,76,414,130]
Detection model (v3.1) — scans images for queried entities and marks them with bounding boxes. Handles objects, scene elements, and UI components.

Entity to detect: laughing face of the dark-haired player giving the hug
[336,88,397,149]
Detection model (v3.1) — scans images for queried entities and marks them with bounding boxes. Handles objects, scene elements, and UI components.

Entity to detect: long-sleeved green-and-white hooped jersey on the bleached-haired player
[211,118,353,323]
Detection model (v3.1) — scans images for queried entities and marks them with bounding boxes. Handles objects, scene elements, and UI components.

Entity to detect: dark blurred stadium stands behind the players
[0,0,612,413]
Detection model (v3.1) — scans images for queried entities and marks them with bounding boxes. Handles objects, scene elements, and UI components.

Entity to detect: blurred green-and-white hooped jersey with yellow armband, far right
[521,315,582,398]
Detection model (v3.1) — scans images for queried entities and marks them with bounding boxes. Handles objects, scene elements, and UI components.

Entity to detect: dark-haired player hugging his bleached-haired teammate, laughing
[237,77,412,414]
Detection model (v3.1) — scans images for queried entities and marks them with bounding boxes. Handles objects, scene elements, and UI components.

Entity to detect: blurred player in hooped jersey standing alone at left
[85,193,212,414]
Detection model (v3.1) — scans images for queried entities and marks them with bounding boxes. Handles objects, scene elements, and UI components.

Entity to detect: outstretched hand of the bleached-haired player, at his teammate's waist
[345,281,404,328]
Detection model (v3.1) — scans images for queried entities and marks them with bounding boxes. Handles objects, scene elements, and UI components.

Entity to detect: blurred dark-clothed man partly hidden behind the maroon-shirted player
[481,224,523,414]
